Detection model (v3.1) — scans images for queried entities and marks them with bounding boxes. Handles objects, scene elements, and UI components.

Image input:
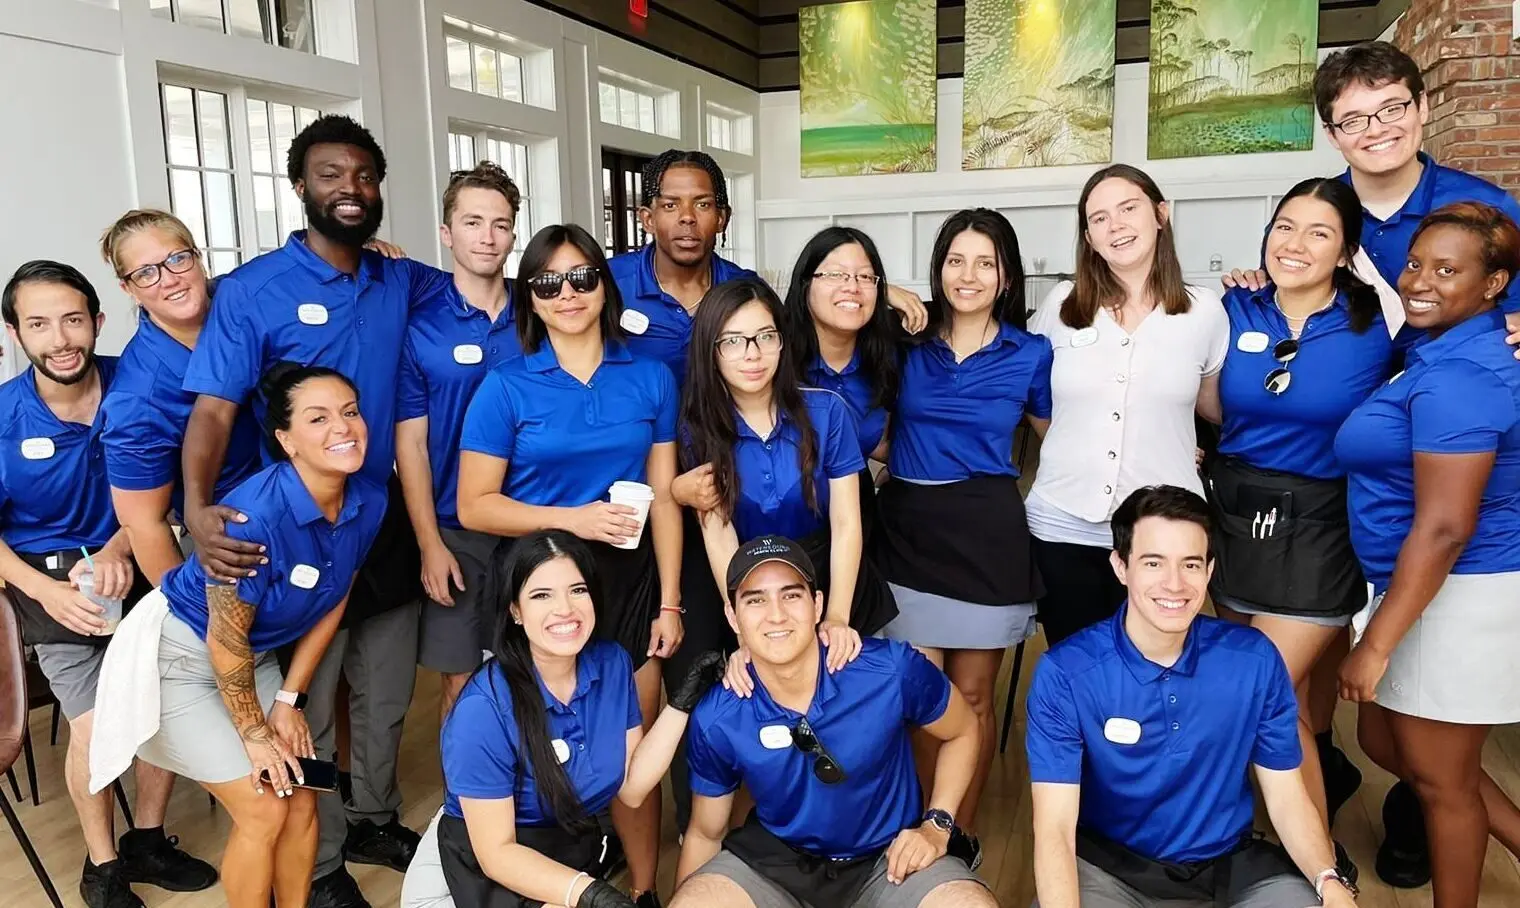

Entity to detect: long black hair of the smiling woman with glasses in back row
[780,227,903,406]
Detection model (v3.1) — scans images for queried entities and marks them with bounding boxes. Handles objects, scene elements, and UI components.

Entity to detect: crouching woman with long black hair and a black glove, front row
[438,532,722,908]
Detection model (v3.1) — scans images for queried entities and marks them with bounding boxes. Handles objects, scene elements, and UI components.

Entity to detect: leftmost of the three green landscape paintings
[798,0,936,176]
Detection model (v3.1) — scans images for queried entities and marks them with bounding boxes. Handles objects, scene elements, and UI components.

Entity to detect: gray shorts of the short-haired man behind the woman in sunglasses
[416,526,512,674]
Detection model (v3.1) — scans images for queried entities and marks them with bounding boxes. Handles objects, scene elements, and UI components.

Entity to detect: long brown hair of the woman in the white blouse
[1061,164,1193,329]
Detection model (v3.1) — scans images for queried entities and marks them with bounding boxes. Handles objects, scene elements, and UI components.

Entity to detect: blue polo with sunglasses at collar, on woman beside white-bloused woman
[1219,284,1394,479]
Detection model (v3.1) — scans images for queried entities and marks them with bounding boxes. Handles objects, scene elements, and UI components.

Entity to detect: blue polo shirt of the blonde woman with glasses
[100,312,263,513]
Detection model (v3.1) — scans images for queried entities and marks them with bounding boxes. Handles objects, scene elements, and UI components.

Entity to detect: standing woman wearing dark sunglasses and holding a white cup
[459,224,682,905]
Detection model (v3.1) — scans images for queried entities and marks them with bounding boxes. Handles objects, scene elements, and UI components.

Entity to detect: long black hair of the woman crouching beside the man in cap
[486,529,602,833]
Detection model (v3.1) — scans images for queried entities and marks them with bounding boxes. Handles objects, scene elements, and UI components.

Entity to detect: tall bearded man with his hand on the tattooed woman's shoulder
[182,116,448,908]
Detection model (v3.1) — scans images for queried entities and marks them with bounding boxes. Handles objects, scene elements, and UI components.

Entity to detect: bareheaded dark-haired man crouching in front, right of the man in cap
[1026,485,1356,908]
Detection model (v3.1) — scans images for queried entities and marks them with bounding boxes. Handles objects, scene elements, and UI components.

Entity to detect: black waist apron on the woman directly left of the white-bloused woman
[874,476,1044,605]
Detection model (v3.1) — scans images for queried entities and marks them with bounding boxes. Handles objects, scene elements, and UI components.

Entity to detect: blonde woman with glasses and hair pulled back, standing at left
[100,208,260,584]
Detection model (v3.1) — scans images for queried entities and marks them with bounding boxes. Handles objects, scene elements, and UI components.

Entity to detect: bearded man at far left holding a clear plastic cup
[0,262,216,908]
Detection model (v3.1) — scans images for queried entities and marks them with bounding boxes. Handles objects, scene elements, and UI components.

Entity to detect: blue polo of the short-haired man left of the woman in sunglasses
[395,281,523,529]
